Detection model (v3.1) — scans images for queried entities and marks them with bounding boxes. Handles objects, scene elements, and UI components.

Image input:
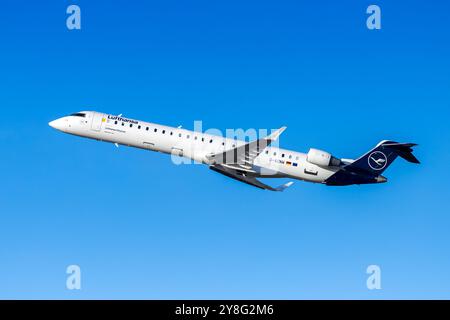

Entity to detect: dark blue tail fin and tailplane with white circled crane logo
[346,140,420,175]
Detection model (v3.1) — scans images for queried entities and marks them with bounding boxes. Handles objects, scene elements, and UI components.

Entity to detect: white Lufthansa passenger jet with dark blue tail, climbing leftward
[49,111,420,191]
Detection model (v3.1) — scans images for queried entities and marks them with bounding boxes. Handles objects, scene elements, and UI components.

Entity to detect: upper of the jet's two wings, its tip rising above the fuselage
[207,127,286,168]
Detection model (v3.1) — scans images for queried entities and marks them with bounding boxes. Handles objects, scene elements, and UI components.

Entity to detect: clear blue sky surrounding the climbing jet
[0,0,450,299]
